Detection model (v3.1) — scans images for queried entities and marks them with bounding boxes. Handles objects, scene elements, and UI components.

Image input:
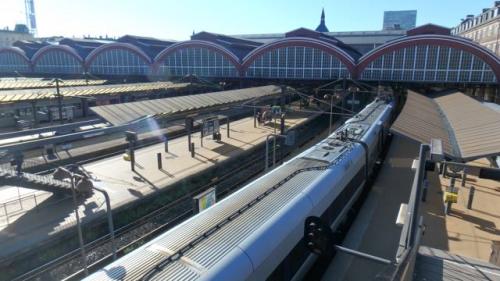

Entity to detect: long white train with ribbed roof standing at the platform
[85,95,393,281]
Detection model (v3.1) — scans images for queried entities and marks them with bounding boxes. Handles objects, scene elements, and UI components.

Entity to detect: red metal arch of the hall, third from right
[153,40,241,71]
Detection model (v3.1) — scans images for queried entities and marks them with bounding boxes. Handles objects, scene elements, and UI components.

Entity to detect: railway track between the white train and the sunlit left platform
[13,142,280,281]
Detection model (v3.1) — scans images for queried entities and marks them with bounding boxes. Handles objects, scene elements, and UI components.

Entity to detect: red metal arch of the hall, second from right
[242,38,356,74]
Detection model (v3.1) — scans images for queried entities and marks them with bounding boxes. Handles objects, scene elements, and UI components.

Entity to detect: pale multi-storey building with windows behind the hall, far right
[452,1,500,56]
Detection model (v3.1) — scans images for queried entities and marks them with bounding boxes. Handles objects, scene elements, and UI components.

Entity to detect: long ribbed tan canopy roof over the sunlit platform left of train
[91,85,281,125]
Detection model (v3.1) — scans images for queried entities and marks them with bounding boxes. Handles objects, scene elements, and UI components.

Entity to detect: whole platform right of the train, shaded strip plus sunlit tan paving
[323,135,500,280]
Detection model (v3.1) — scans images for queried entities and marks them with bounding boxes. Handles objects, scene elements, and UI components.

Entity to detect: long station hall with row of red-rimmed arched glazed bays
[0,24,500,84]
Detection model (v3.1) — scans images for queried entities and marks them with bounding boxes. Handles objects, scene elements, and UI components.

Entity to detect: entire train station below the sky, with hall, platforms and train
[0,0,500,281]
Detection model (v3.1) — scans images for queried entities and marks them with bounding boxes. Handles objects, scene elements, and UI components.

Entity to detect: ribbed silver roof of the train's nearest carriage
[86,155,325,280]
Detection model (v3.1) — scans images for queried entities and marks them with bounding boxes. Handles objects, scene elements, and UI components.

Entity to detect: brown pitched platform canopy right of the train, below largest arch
[391,91,500,162]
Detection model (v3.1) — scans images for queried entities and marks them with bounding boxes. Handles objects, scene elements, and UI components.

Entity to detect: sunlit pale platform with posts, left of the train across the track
[0,113,313,259]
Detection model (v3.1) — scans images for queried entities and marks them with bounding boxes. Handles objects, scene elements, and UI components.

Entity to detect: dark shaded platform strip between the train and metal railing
[322,135,419,281]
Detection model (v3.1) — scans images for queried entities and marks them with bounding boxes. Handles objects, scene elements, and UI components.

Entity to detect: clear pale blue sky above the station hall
[0,0,494,40]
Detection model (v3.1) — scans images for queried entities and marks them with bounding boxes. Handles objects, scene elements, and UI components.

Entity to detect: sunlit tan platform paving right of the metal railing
[422,159,500,262]
